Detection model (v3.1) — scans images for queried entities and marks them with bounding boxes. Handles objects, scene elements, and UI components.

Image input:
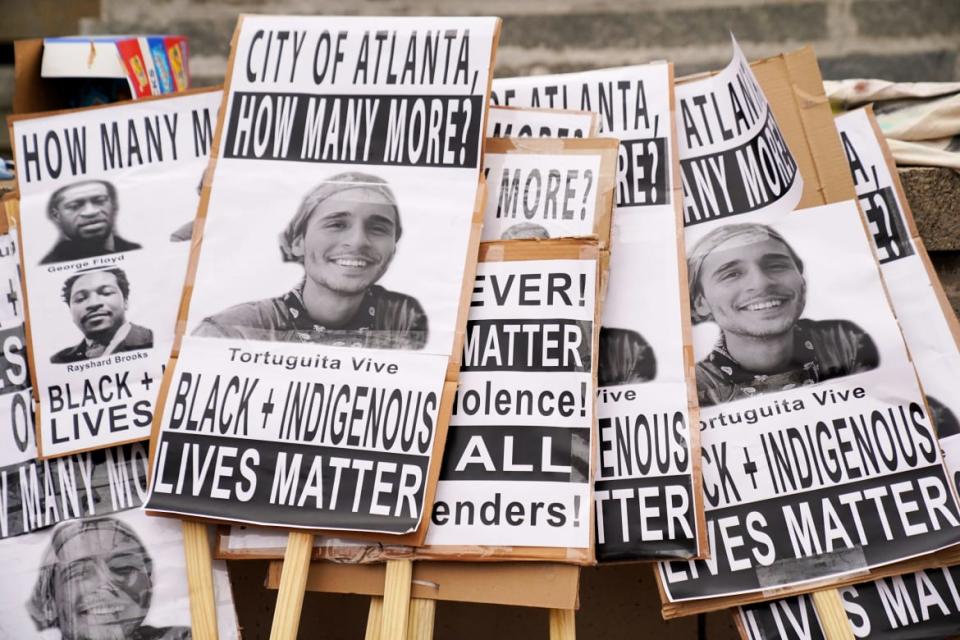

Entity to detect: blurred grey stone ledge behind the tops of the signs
[82,0,960,86]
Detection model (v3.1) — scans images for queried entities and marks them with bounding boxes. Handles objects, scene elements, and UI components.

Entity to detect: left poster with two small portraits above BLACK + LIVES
[11,91,221,457]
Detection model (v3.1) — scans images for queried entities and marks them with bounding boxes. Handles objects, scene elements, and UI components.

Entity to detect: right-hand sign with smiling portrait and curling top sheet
[659,42,957,617]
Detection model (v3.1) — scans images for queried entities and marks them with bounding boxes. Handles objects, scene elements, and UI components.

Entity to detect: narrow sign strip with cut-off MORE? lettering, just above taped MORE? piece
[487,107,600,138]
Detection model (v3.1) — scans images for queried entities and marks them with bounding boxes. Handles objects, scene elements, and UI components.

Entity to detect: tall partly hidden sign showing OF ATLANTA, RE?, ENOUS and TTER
[493,63,706,561]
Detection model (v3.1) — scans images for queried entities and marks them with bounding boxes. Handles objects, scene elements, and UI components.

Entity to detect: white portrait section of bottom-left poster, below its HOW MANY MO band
[0,504,240,640]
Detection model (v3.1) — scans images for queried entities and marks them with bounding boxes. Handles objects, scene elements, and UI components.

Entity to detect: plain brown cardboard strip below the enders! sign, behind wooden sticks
[266,562,580,609]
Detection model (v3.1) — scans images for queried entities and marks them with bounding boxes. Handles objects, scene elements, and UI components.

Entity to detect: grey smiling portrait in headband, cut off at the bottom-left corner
[27,518,192,640]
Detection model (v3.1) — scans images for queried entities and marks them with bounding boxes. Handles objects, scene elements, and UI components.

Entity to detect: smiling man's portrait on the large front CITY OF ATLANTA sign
[193,172,428,349]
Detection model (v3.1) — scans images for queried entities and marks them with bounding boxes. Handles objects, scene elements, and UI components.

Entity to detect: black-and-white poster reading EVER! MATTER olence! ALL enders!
[427,257,598,551]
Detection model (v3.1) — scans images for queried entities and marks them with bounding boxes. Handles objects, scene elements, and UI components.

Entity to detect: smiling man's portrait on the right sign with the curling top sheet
[687,223,880,406]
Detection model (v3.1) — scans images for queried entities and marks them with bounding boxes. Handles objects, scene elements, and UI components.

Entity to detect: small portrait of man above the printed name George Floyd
[40,180,141,264]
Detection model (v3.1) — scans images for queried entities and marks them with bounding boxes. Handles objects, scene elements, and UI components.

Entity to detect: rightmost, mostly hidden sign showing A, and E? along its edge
[738,108,960,640]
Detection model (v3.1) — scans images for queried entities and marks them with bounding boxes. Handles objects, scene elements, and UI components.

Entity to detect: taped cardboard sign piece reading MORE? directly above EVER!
[481,138,618,242]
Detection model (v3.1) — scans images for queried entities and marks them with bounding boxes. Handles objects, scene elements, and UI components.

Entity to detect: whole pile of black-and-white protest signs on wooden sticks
[0,16,960,640]
